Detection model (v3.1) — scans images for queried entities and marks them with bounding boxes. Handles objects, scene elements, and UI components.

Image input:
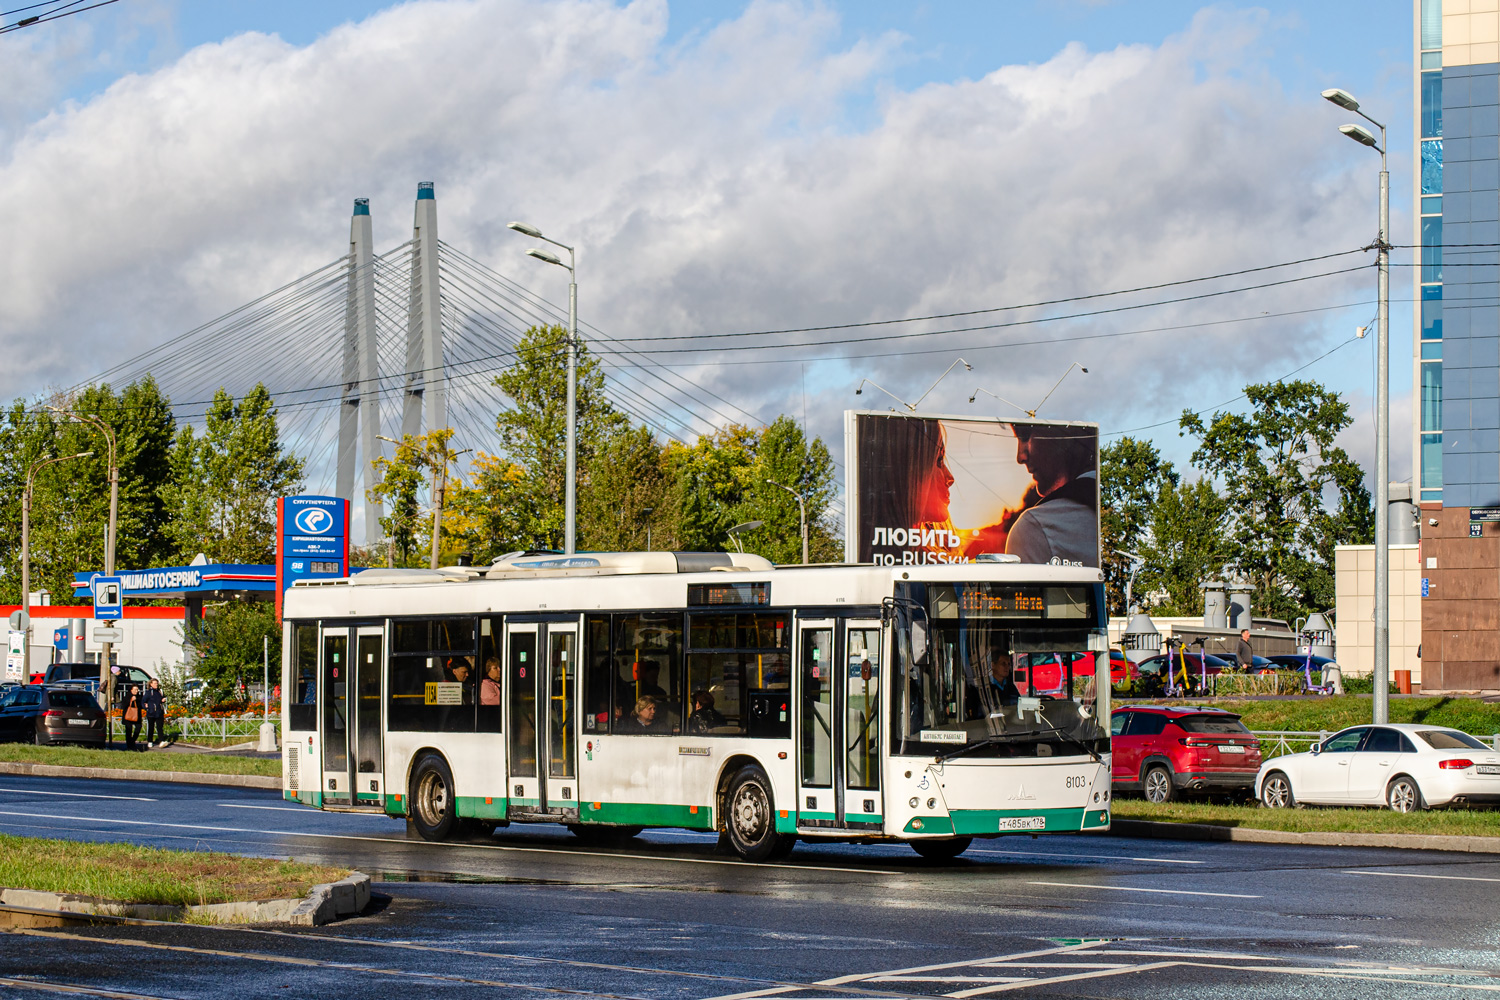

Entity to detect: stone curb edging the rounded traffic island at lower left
[0,871,371,927]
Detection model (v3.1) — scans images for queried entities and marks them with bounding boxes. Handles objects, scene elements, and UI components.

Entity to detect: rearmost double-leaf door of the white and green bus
[318,625,386,807]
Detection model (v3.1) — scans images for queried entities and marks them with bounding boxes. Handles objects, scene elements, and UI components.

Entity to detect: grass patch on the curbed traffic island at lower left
[0,834,350,906]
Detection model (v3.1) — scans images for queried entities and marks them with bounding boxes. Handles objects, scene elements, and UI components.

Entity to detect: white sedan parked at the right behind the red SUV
[1256,724,1500,813]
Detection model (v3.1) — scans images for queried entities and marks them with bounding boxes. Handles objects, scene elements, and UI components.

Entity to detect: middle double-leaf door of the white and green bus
[506,622,578,819]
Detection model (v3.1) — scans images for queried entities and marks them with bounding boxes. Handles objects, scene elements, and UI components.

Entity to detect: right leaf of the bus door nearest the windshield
[834,619,885,831]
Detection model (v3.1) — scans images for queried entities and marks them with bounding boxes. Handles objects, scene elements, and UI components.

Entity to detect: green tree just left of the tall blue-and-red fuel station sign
[162,385,303,562]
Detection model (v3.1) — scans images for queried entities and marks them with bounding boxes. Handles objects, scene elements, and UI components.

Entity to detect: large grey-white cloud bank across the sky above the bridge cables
[0,0,1392,485]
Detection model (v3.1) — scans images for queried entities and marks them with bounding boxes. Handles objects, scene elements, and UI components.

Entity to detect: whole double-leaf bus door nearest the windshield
[797,619,882,834]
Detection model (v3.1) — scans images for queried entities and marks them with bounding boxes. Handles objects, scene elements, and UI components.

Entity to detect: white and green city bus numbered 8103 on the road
[282,552,1110,861]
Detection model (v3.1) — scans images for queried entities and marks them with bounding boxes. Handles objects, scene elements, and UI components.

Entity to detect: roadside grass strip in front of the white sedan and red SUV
[1113,798,1500,837]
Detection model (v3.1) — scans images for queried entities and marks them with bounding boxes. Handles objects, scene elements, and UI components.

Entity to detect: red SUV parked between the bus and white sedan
[1110,705,1260,802]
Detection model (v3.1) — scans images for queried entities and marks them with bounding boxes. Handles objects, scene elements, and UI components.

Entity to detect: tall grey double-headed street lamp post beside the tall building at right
[1323,88,1391,724]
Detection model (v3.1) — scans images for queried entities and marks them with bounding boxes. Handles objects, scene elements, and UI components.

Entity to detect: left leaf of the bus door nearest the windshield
[797,619,842,826]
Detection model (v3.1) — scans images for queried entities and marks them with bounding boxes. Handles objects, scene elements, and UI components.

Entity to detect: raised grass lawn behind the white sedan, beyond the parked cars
[1128,694,1500,736]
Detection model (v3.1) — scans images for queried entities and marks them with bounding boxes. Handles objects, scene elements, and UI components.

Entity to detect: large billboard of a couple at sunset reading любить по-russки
[845,409,1100,567]
